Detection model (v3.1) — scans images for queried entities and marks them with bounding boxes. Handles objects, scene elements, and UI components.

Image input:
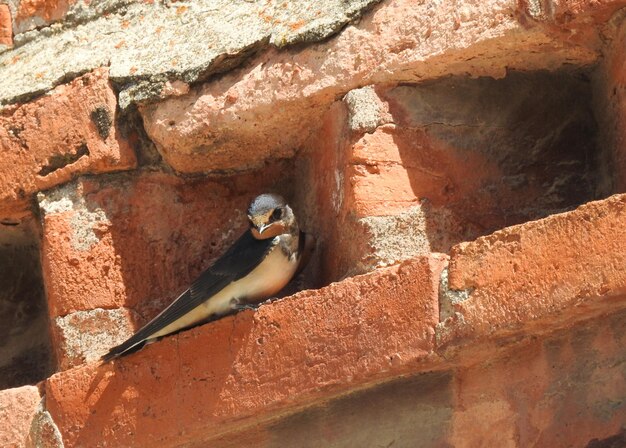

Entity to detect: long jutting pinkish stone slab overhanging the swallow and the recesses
[142,0,604,172]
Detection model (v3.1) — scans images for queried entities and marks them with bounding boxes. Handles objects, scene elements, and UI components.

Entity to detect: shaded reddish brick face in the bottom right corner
[449,311,626,448]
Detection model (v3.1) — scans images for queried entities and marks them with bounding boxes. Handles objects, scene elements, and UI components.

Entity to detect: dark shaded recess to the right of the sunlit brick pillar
[385,72,598,238]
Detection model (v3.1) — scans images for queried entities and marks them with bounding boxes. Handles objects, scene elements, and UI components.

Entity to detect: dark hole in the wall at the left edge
[0,218,53,389]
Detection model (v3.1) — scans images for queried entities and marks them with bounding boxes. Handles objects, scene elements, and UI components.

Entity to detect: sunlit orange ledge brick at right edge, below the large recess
[439,195,626,343]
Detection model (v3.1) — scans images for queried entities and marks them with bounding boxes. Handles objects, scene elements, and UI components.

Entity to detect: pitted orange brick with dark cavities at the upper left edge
[0,70,136,218]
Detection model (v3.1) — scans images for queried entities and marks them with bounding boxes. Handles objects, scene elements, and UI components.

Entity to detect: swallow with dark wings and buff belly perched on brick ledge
[101,193,314,362]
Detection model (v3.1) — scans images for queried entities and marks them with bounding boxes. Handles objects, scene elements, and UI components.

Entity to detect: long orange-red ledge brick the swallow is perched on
[46,257,445,447]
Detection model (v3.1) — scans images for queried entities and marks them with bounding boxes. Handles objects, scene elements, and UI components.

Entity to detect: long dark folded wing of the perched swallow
[102,231,275,361]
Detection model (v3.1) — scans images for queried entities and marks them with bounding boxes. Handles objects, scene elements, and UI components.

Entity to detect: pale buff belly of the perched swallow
[150,247,298,339]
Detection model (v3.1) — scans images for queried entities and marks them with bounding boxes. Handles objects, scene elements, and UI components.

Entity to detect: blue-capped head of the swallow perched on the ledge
[248,194,297,240]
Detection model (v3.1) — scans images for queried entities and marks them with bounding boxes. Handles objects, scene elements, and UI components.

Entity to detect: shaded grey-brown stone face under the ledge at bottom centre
[210,372,454,448]
